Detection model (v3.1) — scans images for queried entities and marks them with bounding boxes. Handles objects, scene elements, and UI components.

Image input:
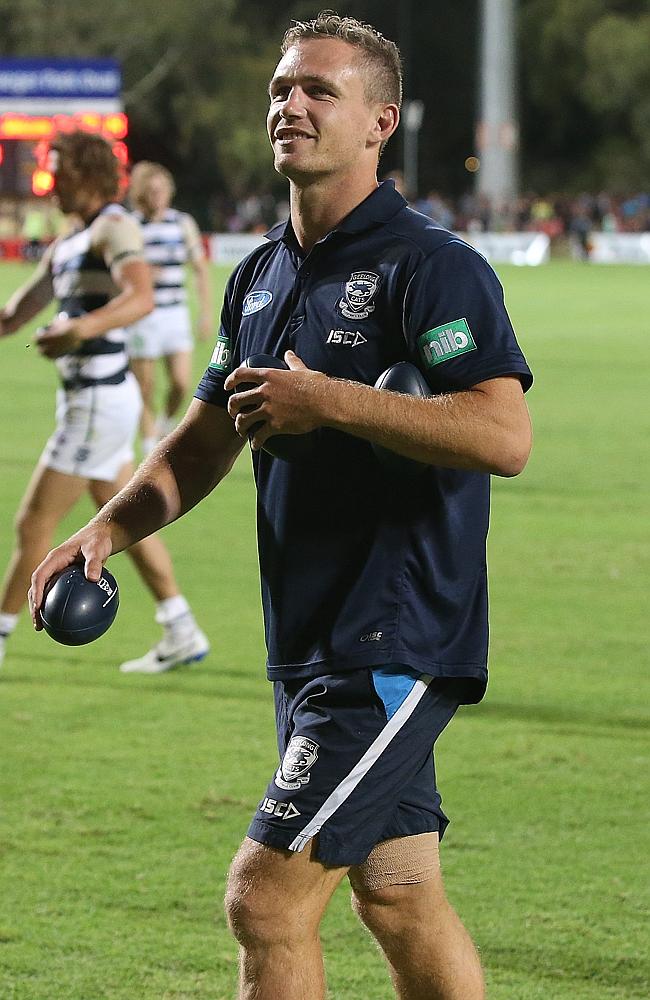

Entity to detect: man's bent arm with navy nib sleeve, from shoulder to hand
[226,238,532,476]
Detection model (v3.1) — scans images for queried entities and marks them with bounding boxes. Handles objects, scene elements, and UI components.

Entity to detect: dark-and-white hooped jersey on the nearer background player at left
[44,203,142,386]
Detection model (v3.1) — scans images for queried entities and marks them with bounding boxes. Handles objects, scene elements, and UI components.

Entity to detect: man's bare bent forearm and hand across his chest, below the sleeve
[226,351,532,476]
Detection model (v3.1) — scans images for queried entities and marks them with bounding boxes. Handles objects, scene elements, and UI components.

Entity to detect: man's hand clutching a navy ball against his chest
[225,351,330,451]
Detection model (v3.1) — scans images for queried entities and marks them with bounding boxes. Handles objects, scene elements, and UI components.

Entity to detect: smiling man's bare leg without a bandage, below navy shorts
[226,837,347,1000]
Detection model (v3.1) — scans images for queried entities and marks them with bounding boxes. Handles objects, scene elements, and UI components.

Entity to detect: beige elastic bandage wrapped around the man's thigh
[348,833,440,892]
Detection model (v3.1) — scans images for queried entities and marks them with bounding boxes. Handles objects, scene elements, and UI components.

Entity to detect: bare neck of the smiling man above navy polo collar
[291,177,378,252]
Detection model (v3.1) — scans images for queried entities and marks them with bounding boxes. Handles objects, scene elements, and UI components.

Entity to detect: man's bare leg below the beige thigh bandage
[352,834,485,1000]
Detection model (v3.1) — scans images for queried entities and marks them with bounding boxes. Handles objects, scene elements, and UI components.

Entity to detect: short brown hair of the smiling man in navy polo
[281,10,402,107]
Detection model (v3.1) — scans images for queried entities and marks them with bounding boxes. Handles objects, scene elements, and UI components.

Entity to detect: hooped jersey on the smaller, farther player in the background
[133,208,203,309]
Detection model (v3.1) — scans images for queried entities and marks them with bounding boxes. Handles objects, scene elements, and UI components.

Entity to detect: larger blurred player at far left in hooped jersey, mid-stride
[0,132,209,673]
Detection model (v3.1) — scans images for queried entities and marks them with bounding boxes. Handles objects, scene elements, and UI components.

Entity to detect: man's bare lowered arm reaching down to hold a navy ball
[29,399,244,629]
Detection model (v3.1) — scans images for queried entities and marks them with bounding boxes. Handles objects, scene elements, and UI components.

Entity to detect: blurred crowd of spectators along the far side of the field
[0,184,650,259]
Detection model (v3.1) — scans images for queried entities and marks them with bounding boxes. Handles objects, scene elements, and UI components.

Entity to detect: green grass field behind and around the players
[0,263,650,1000]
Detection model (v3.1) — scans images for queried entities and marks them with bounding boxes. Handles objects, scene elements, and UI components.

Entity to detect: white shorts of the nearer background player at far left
[41,372,142,483]
